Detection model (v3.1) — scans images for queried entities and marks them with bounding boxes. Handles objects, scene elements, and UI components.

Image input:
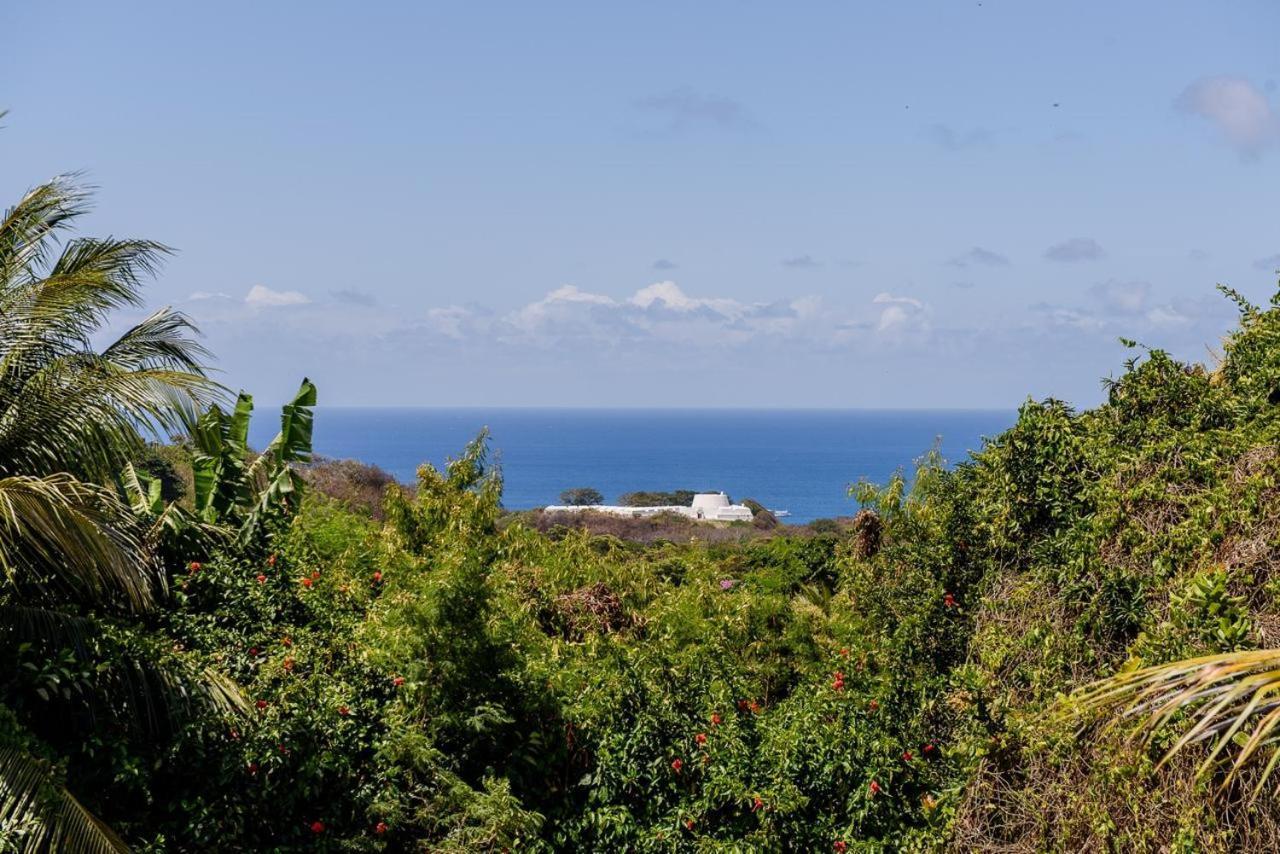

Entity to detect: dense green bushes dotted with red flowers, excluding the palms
[32,281,1280,851]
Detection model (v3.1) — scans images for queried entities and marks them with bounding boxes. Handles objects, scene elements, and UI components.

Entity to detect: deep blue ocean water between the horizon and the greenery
[251,406,1016,522]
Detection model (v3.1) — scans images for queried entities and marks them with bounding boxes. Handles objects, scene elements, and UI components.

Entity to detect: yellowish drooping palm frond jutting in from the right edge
[1068,649,1280,798]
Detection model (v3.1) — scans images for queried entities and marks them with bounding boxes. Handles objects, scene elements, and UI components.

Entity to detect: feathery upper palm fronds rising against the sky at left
[0,178,225,479]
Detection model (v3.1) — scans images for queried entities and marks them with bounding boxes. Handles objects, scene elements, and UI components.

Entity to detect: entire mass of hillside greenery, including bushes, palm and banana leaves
[0,170,1280,851]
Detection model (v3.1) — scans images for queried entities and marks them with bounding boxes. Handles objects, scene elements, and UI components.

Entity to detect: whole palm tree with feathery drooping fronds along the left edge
[0,177,236,851]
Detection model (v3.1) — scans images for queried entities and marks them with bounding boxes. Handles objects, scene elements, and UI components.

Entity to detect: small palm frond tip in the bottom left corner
[0,748,129,854]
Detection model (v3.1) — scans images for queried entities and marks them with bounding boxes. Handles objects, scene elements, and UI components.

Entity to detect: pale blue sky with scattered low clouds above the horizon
[0,0,1280,408]
